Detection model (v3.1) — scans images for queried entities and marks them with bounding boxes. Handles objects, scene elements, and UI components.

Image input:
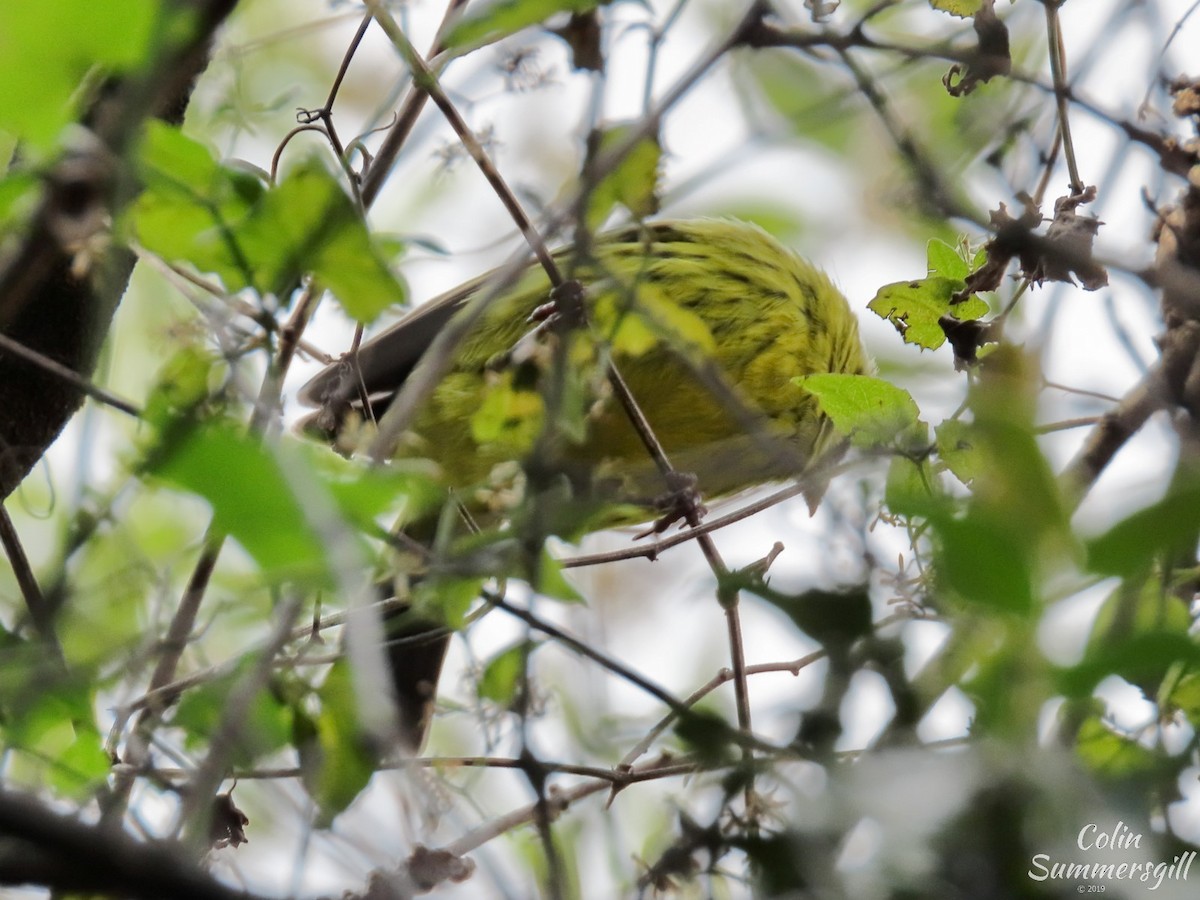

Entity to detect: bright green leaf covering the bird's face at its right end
[794,372,929,451]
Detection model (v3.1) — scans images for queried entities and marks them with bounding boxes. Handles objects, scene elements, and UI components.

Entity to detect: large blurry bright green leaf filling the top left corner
[0,0,162,149]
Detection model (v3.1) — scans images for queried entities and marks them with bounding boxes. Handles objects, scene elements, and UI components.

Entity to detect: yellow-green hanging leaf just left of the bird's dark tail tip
[295,658,376,828]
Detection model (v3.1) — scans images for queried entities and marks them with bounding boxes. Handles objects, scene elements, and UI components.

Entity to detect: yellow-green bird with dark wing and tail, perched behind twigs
[301,218,869,749]
